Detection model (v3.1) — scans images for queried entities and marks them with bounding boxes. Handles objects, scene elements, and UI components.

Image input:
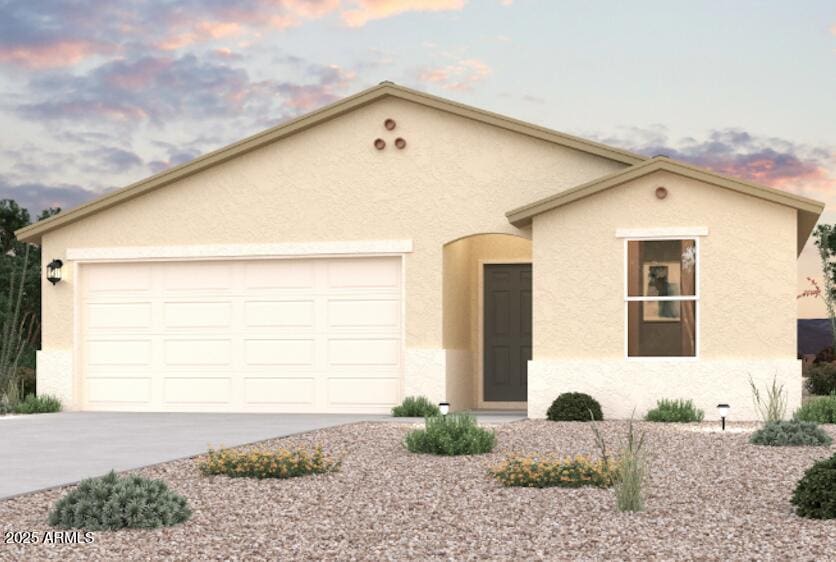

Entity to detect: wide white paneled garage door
[80,257,403,412]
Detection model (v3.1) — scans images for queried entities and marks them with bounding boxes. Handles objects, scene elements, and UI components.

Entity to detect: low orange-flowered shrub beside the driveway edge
[198,447,340,479]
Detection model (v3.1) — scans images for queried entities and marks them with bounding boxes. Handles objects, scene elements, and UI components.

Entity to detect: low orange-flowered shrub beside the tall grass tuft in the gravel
[489,455,615,488]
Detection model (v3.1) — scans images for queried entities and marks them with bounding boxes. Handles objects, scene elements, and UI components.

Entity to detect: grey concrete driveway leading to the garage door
[0,412,384,498]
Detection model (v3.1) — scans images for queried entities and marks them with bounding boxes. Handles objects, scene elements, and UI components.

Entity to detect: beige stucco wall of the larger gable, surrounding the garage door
[43,98,624,402]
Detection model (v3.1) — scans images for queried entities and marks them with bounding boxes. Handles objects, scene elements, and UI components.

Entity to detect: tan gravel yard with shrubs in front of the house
[0,421,836,560]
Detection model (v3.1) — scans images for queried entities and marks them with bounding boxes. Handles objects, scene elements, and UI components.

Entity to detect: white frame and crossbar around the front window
[623,234,702,362]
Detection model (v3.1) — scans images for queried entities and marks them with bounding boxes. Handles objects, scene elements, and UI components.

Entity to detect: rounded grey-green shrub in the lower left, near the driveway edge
[49,471,192,531]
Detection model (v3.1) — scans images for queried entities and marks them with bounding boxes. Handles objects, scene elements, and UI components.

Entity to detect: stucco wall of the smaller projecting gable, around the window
[529,168,801,419]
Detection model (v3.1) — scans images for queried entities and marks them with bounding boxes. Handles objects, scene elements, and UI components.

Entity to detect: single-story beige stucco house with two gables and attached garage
[18,82,823,419]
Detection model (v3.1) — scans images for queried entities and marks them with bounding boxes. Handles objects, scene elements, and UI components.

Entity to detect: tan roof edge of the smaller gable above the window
[505,156,824,253]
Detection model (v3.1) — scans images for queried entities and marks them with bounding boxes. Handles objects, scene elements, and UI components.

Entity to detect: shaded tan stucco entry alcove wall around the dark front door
[443,232,531,410]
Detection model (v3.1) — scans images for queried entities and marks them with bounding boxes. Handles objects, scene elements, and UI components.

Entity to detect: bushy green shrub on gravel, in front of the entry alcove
[404,414,496,455]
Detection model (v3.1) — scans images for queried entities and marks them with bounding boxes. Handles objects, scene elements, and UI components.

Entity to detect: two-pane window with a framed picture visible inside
[625,239,699,357]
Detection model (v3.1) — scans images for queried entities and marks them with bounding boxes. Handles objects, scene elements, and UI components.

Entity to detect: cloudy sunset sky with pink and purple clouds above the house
[0,0,836,317]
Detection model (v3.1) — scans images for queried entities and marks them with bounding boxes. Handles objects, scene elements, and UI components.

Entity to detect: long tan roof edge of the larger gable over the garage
[15,82,646,242]
